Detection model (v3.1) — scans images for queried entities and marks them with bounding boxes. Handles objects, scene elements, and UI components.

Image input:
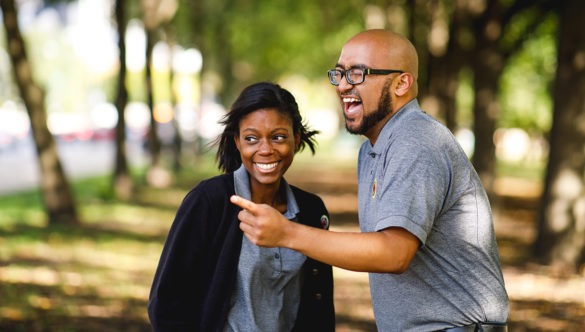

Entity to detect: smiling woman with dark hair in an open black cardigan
[148,82,335,331]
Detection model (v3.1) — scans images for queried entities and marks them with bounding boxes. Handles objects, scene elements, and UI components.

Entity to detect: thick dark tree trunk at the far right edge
[534,0,585,272]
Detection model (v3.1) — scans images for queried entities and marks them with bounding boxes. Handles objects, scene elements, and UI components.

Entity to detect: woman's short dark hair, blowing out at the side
[216,82,319,173]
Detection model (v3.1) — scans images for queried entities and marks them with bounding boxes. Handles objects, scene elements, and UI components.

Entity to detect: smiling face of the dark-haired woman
[234,108,300,189]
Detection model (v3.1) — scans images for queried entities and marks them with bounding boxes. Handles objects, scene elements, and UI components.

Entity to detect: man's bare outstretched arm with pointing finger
[231,196,419,273]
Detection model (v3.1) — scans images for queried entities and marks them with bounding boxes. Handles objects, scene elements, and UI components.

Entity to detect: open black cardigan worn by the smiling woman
[148,173,335,331]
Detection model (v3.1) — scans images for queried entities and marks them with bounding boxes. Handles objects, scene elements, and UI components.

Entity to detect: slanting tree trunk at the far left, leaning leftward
[0,0,78,224]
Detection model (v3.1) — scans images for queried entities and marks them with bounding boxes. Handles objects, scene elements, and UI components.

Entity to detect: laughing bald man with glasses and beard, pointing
[232,30,509,331]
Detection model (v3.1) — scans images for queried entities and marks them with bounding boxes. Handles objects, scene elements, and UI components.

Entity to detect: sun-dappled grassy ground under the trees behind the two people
[0,151,585,332]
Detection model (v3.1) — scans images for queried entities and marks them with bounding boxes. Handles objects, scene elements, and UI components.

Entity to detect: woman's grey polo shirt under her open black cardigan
[225,165,306,332]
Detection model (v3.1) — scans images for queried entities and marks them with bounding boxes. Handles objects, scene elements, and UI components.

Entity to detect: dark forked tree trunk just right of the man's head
[460,0,555,197]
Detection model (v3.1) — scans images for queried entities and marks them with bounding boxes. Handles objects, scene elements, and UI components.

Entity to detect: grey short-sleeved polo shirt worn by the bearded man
[358,100,508,332]
